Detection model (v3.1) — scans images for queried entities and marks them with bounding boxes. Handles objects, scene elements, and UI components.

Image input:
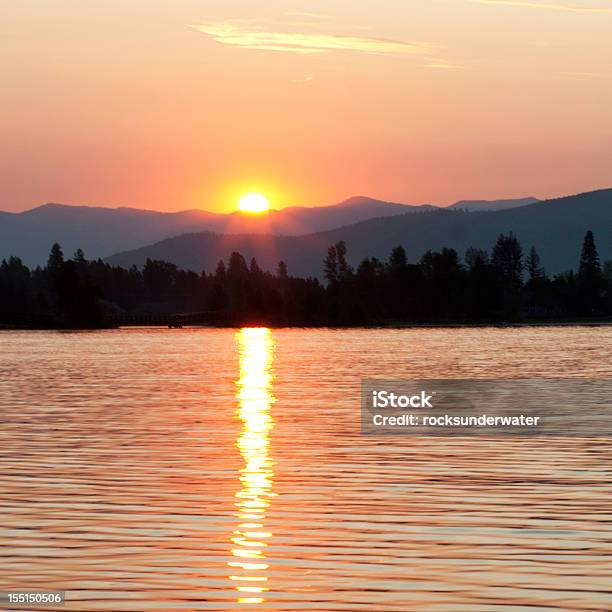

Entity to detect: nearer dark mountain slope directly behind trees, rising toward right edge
[108,189,612,276]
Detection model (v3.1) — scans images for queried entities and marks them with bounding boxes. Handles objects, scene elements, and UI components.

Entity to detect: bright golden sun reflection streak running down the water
[228,327,275,604]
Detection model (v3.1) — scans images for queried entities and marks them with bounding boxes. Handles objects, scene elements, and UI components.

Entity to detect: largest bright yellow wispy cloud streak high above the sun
[191,19,433,55]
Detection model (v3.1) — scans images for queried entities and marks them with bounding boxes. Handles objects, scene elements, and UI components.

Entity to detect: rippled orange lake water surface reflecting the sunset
[0,328,612,612]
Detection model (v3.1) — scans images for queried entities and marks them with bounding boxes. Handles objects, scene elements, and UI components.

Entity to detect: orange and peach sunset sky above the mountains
[0,0,612,211]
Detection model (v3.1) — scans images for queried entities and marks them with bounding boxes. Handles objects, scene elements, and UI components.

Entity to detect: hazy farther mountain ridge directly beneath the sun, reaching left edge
[0,196,532,266]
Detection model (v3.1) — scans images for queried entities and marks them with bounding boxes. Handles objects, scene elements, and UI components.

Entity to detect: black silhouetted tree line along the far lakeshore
[0,231,612,328]
